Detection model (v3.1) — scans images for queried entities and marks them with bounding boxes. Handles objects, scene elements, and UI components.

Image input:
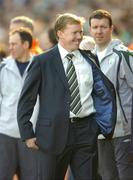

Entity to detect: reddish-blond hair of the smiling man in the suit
[54,13,85,38]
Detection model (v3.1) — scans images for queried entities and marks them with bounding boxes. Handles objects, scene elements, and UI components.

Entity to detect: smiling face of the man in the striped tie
[57,24,83,52]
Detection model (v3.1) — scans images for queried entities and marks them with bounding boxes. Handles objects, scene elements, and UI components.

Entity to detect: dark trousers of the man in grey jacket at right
[98,135,133,180]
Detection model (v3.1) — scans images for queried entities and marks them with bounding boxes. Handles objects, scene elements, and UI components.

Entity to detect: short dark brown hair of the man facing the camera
[89,9,113,27]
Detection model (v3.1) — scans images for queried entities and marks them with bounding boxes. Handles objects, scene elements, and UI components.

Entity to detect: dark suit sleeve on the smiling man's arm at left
[17,57,41,140]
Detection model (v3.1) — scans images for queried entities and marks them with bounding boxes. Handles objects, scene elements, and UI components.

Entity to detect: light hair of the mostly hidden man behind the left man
[10,16,34,32]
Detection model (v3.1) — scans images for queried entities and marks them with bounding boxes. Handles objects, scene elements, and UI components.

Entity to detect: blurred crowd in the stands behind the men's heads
[0,0,133,56]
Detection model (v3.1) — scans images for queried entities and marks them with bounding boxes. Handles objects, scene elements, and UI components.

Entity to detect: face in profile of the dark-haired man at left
[9,33,25,60]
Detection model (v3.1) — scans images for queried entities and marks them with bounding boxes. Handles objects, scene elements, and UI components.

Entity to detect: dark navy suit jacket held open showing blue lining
[17,46,116,154]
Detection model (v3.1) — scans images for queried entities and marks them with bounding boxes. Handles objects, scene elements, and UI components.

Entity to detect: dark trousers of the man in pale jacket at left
[0,134,38,180]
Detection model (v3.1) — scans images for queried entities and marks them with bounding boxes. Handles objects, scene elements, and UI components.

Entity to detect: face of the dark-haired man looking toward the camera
[90,18,113,47]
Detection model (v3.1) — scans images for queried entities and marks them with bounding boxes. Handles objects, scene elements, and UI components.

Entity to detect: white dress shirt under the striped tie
[58,43,96,118]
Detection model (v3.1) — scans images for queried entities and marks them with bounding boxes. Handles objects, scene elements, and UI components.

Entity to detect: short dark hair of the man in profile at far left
[9,27,33,49]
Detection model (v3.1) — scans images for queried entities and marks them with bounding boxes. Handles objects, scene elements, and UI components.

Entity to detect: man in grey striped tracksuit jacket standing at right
[89,9,133,180]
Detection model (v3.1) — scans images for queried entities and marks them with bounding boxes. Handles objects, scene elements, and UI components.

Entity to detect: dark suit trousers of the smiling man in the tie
[38,115,99,180]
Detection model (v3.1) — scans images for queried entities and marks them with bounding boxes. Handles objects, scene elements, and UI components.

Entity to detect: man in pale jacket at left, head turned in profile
[0,28,38,180]
